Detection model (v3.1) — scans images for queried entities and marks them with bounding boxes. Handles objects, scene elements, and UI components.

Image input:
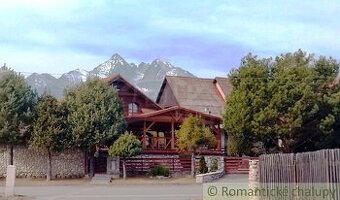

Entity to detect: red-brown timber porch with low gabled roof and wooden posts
[126,106,223,154]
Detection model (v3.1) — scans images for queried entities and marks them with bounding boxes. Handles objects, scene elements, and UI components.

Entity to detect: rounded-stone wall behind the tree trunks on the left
[0,146,85,178]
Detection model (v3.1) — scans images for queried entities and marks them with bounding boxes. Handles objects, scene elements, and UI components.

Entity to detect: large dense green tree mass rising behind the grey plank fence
[223,50,339,155]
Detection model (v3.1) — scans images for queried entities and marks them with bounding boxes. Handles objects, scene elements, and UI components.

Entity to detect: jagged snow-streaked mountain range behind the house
[21,54,194,99]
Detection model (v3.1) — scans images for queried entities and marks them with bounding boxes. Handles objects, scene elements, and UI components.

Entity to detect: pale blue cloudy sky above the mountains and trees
[0,0,340,77]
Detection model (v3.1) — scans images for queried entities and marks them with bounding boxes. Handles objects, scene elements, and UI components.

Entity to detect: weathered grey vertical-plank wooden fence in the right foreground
[259,149,340,200]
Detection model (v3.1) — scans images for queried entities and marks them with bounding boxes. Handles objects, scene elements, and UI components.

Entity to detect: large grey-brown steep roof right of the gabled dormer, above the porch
[156,76,231,116]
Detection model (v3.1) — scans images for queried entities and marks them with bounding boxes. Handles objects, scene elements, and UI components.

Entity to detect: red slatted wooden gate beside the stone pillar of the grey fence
[224,156,259,174]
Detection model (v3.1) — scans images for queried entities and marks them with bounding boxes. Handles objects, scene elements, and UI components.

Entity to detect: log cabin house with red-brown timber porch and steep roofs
[95,74,231,173]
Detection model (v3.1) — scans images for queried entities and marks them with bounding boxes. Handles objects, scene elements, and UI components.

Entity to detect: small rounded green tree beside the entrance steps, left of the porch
[109,132,142,179]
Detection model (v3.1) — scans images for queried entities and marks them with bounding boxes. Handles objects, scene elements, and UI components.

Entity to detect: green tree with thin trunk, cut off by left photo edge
[0,71,36,164]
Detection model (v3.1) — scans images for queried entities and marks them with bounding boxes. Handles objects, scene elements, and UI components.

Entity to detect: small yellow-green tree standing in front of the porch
[176,115,216,177]
